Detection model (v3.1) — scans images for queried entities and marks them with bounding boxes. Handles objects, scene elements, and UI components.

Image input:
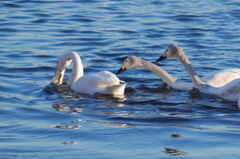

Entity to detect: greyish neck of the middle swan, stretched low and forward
[139,59,177,86]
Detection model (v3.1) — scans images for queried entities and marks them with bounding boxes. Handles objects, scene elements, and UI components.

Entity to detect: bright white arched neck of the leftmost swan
[67,52,83,86]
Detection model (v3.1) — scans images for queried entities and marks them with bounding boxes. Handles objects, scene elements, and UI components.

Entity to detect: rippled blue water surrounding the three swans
[0,0,240,159]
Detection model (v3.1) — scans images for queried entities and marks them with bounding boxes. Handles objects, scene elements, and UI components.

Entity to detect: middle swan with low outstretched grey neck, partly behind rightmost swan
[117,56,240,91]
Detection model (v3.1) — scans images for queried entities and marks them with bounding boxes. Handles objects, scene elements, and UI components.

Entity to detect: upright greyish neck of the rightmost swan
[177,49,204,88]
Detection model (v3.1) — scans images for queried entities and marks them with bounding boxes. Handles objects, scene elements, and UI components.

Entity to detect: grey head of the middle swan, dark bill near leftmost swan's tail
[116,56,141,74]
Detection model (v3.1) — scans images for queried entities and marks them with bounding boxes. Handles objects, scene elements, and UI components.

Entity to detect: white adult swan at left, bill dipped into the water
[52,52,126,95]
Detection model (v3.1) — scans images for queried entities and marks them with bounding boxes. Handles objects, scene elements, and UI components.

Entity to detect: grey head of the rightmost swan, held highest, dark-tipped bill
[156,45,182,62]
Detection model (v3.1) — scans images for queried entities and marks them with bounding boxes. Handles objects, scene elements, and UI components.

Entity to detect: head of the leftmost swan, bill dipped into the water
[52,53,72,85]
